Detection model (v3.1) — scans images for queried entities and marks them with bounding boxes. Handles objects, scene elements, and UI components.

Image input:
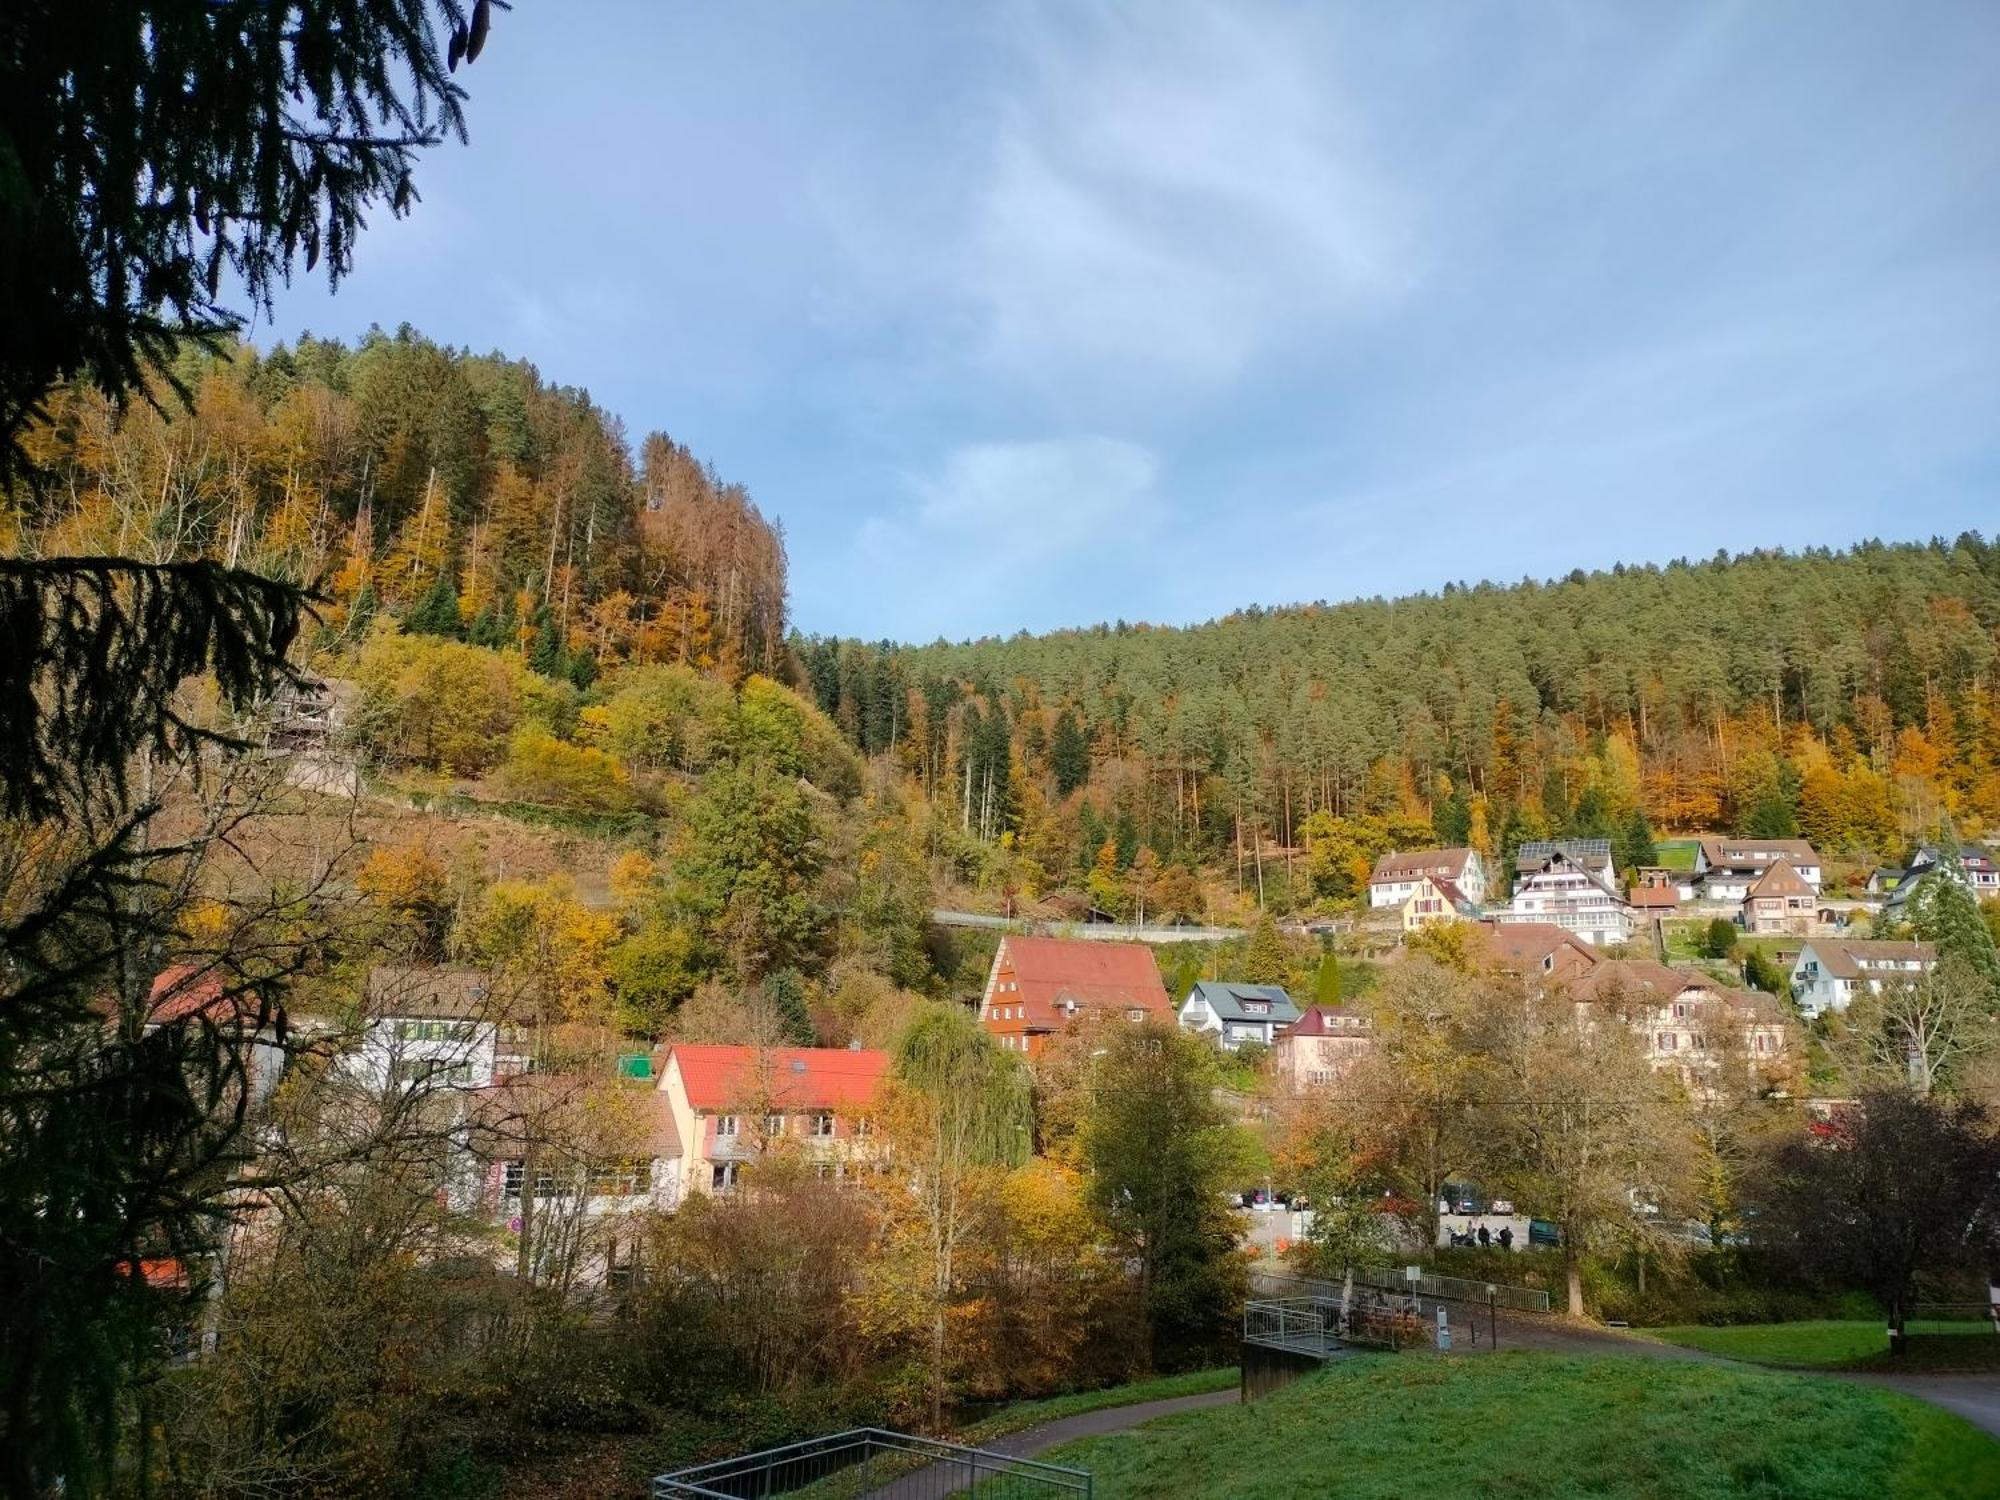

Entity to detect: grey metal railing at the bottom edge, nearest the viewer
[652,1428,1090,1500]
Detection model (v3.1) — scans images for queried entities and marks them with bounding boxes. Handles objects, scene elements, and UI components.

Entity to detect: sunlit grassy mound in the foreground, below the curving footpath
[1046,1352,2000,1500]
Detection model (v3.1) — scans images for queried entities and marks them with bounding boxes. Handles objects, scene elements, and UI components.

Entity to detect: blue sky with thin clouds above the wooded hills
[254,0,2000,640]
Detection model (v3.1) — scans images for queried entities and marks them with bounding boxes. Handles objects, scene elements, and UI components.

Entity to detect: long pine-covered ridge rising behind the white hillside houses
[796,536,2000,904]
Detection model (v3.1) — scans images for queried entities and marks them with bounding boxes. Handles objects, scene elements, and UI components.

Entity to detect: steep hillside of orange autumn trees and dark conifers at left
[0,326,784,680]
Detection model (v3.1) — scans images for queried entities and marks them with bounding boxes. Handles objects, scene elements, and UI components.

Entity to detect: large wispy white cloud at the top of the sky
[964,4,1410,382]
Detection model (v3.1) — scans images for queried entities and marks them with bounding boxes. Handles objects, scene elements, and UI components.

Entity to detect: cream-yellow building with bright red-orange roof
[660,1044,888,1194]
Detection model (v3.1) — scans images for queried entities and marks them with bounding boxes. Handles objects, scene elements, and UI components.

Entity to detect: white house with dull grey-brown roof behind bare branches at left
[346,966,528,1088]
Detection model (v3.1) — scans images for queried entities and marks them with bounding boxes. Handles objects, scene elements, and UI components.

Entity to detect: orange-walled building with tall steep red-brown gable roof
[980,934,1174,1058]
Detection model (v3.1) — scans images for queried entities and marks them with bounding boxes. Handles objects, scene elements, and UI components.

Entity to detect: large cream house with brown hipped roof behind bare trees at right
[1572,958,1790,1092]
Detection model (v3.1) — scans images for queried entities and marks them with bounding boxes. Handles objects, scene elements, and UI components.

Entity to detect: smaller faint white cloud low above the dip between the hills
[848,436,1162,630]
